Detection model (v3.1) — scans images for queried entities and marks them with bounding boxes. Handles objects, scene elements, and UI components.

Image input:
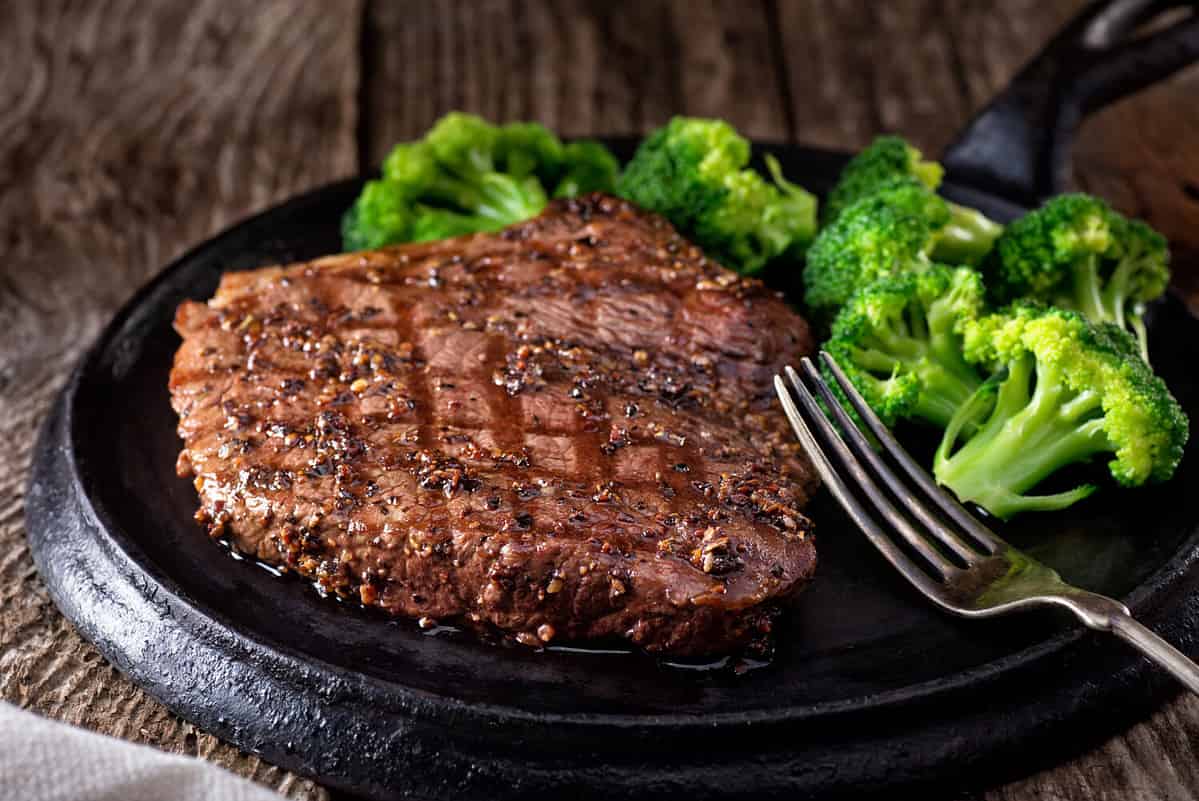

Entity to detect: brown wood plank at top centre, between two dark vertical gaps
[364,0,789,163]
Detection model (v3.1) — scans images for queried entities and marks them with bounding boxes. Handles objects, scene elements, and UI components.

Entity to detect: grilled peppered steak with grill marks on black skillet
[170,194,815,655]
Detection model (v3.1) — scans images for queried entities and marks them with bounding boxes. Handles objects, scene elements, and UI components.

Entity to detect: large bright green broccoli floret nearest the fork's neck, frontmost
[933,301,1188,519]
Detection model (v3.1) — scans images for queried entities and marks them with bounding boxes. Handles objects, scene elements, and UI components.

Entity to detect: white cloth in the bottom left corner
[0,703,279,801]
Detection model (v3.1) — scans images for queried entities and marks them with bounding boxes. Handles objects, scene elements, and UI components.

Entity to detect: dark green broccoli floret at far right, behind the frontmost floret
[983,194,1170,359]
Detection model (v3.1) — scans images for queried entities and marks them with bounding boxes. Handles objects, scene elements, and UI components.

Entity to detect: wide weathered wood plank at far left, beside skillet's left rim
[0,0,359,799]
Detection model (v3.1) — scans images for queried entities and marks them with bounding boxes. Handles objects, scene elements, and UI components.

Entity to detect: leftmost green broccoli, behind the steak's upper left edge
[342,112,619,249]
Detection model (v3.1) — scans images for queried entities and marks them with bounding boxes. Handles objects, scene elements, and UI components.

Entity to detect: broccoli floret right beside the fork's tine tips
[825,265,984,428]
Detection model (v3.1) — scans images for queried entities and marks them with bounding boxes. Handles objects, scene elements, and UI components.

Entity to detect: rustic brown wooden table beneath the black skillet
[7,0,1199,801]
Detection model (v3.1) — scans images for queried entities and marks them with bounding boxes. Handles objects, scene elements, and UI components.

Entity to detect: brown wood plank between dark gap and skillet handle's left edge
[777,0,1080,153]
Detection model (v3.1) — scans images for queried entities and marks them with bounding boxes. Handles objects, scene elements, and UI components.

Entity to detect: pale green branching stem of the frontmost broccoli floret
[933,355,1110,519]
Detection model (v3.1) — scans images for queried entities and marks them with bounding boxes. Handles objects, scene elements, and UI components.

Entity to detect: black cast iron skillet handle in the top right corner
[941,0,1199,206]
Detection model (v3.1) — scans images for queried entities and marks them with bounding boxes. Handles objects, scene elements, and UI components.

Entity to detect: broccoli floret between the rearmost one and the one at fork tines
[803,179,990,318]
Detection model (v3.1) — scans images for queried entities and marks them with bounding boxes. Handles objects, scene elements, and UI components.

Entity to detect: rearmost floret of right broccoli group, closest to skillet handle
[823,137,1004,264]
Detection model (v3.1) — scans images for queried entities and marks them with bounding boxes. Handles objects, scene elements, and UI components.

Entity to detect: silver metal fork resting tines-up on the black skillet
[775,351,1199,693]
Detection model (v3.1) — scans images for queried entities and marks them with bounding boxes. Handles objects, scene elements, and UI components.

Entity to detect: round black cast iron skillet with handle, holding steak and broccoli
[26,1,1199,800]
